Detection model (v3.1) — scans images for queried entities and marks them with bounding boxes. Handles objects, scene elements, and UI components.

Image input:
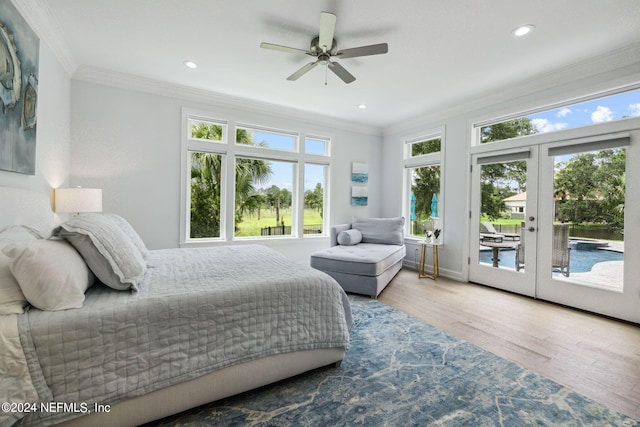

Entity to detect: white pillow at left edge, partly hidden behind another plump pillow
[0,225,41,315]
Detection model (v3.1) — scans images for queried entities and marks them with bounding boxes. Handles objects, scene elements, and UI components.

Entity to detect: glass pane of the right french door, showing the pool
[550,148,626,291]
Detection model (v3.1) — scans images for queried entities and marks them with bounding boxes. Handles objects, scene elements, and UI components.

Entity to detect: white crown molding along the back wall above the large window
[72,65,382,137]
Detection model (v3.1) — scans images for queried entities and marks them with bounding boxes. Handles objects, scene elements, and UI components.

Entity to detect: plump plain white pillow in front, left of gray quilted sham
[2,239,94,311]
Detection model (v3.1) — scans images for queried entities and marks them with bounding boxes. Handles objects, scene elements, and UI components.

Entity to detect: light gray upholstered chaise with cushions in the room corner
[311,217,406,298]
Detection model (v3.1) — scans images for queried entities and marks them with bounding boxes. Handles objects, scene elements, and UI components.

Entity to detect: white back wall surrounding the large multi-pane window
[71,80,382,263]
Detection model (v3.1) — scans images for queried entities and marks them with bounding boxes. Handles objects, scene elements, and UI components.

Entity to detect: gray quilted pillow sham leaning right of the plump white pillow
[53,214,147,291]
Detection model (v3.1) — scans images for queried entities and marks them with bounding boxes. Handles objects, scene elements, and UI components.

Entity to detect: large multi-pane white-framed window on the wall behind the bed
[181,110,330,244]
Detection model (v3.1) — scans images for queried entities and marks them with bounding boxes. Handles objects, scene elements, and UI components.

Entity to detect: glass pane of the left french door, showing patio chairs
[478,160,527,272]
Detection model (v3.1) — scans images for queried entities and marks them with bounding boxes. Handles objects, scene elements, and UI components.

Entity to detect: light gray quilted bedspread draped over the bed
[19,245,352,425]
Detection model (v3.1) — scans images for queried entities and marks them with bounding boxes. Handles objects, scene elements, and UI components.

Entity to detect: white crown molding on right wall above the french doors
[383,43,640,135]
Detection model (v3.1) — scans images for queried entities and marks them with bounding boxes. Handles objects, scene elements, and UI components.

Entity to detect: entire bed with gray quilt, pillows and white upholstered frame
[0,187,352,426]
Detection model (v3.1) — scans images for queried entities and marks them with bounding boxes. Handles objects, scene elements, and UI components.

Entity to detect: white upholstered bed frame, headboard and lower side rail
[0,187,345,426]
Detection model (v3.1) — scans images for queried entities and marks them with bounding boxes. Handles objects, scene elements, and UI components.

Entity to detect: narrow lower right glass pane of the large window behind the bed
[302,163,329,235]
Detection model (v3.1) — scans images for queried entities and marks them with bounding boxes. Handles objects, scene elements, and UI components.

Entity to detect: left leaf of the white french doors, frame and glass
[469,146,538,297]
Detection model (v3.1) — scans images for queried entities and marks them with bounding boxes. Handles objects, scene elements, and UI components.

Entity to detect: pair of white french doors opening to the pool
[469,130,640,322]
